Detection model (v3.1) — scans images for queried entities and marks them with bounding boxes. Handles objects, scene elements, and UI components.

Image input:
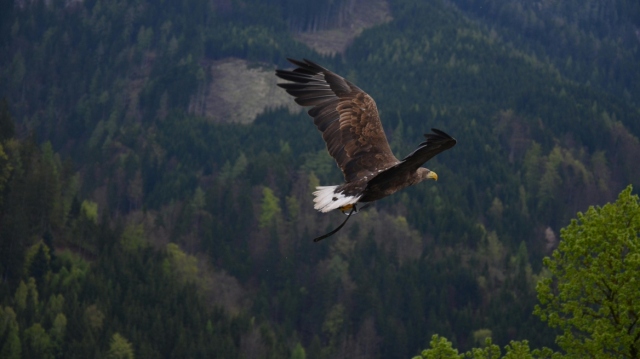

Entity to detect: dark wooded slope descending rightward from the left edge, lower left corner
[0,112,288,358]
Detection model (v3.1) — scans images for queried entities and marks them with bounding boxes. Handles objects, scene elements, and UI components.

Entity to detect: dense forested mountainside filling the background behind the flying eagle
[0,0,640,359]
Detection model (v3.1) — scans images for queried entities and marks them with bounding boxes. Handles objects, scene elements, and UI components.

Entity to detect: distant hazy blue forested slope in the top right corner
[453,0,640,109]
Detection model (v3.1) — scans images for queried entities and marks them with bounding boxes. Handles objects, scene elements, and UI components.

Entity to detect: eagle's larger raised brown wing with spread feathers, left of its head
[276,59,399,182]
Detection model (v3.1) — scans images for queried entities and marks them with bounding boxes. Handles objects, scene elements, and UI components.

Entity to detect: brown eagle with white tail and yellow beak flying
[276,58,456,242]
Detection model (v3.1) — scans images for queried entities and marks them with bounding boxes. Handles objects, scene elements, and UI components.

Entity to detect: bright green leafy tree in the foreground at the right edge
[535,186,640,358]
